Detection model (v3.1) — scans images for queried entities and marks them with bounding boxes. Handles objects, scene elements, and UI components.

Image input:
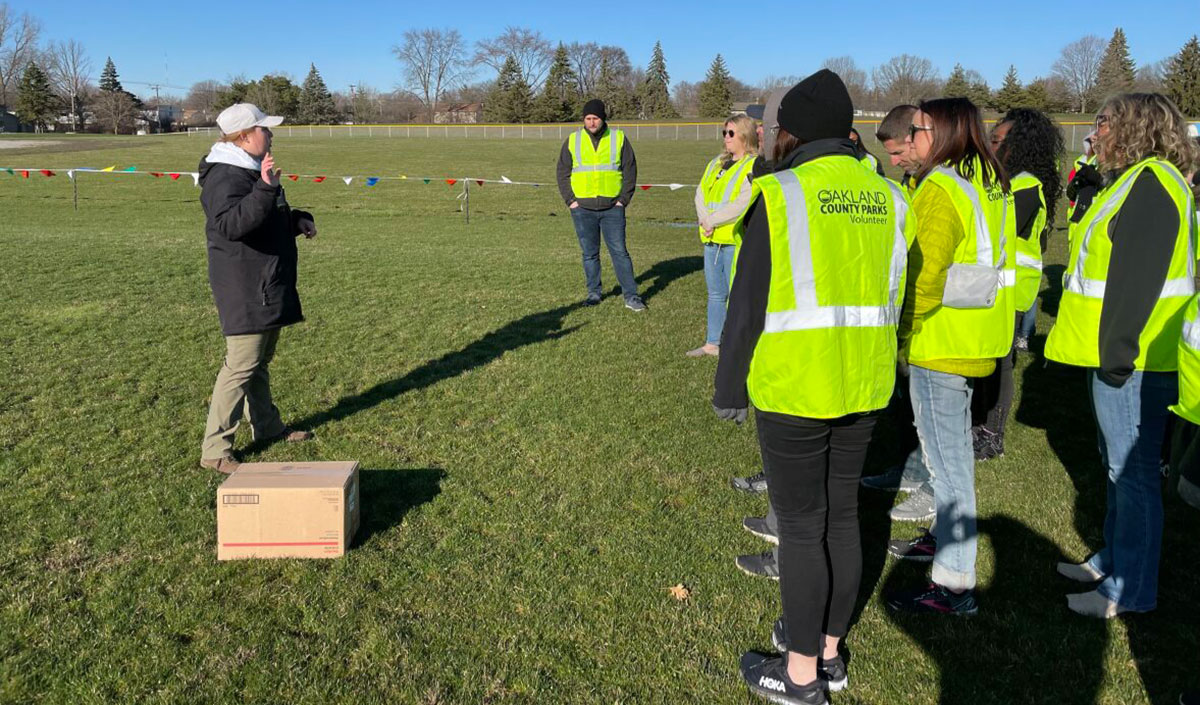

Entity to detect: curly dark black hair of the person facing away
[996,108,1067,227]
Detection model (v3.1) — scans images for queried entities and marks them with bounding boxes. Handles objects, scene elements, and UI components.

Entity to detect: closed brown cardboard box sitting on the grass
[217,460,359,561]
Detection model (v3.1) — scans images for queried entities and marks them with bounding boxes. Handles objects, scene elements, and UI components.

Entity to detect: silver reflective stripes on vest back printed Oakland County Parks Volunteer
[763,169,908,333]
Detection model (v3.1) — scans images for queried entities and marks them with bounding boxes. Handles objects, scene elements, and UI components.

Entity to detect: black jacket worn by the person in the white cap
[199,159,312,336]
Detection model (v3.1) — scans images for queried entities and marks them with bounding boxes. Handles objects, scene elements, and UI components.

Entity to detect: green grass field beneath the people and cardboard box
[0,137,1200,705]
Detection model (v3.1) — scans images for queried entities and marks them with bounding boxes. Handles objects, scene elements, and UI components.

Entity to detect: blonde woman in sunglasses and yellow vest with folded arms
[686,115,758,357]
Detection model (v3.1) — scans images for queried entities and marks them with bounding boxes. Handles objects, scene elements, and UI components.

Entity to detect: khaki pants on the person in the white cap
[200,329,284,459]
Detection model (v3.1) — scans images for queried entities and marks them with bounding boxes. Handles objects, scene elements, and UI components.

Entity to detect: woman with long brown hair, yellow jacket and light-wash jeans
[887,98,1016,615]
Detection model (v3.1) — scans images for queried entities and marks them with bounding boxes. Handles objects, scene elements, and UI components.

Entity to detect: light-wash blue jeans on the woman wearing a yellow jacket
[908,366,978,592]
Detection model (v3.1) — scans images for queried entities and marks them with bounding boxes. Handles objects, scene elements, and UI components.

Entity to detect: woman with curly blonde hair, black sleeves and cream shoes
[1046,94,1200,619]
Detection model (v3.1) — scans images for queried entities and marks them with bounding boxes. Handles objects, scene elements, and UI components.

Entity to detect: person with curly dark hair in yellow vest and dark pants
[972,108,1066,460]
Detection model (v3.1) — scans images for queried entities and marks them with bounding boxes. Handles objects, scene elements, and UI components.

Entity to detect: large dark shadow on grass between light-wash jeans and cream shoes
[883,516,1108,705]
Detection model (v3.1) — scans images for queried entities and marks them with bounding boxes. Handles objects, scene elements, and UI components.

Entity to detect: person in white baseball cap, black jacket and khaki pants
[199,103,317,474]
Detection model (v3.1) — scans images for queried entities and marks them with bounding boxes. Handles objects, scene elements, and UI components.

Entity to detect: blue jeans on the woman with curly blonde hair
[1087,369,1180,611]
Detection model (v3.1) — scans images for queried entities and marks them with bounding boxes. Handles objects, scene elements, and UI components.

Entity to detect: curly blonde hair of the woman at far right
[1093,94,1200,174]
